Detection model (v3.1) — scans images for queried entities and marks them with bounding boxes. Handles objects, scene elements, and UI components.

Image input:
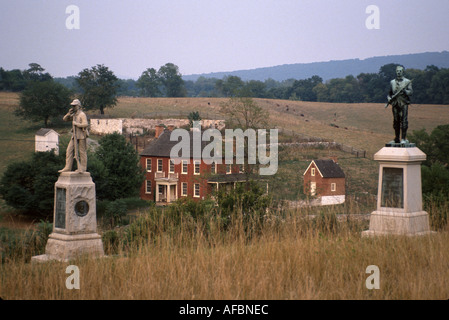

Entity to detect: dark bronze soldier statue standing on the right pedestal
[385,66,413,143]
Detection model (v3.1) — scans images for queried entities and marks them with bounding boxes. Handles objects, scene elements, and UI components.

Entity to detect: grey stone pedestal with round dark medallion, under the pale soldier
[31,172,104,262]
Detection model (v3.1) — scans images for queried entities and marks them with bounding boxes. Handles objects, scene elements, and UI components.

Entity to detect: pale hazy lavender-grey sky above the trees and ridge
[0,0,449,79]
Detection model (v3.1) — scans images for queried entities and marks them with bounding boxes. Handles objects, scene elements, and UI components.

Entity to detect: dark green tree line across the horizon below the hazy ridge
[0,63,449,105]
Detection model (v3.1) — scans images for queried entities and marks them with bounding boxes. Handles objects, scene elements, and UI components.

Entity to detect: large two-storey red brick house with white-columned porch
[140,129,246,203]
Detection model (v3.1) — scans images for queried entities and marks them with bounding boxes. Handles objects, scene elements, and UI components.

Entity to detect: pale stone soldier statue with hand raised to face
[59,99,89,173]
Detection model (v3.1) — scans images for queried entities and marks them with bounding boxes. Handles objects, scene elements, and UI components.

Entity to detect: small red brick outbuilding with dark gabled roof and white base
[304,159,346,205]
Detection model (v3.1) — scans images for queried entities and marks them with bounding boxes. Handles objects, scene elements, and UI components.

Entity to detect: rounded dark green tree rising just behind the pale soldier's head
[76,64,120,114]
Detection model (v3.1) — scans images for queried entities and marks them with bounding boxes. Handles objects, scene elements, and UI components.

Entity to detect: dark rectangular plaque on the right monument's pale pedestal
[381,167,404,208]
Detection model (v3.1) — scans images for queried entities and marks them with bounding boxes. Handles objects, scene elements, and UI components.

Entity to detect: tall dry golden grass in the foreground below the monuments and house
[0,202,449,300]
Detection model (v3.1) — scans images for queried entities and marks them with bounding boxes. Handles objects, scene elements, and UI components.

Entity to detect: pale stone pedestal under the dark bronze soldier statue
[362,144,432,237]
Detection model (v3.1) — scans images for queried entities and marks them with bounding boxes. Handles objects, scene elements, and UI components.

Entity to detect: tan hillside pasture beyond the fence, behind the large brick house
[106,97,449,155]
